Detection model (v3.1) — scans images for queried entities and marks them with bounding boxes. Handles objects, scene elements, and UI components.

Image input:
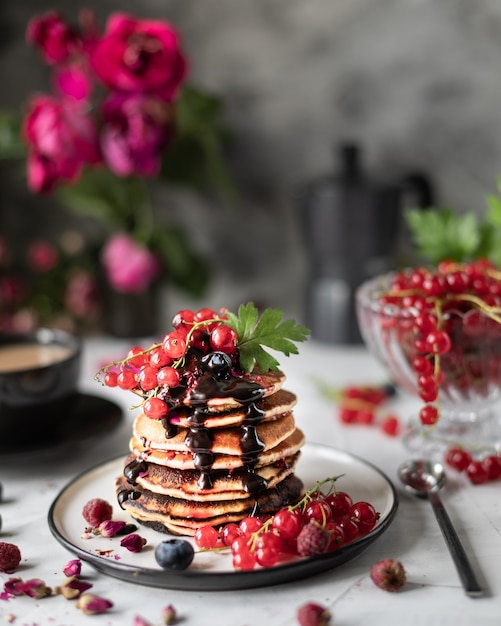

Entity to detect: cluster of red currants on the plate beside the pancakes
[194,478,379,570]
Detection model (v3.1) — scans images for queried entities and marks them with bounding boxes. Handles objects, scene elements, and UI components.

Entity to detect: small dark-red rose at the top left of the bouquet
[26,11,81,65]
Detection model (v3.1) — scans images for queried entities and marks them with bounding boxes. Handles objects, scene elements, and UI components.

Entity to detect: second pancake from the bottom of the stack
[124,452,300,502]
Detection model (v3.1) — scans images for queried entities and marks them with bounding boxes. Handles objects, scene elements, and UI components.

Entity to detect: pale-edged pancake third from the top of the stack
[132,413,295,455]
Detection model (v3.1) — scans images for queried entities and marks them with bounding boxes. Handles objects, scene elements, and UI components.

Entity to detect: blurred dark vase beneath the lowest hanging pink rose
[99,284,160,339]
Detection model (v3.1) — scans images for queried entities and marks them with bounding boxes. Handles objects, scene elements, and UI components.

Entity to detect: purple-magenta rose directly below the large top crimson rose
[101,94,172,176]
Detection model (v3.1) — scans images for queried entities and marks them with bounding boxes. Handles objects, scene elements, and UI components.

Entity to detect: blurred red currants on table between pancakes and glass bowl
[336,385,400,437]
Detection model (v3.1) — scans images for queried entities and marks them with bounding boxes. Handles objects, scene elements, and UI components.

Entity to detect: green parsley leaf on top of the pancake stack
[228,302,310,372]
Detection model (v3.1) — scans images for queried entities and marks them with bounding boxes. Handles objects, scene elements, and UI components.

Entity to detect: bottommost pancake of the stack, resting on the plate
[116,474,303,535]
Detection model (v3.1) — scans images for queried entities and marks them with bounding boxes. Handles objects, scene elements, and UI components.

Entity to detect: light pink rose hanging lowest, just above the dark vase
[101,233,160,293]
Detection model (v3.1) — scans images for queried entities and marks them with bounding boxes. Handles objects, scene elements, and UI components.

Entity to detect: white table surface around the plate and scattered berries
[0,338,501,626]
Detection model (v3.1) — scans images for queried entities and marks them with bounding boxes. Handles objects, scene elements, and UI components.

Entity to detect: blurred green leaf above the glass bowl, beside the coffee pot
[405,208,485,264]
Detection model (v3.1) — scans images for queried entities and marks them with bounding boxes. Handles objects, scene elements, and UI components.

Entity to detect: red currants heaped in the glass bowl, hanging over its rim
[380,260,501,426]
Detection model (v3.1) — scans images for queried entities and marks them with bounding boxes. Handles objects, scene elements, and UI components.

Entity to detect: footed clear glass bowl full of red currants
[356,260,501,454]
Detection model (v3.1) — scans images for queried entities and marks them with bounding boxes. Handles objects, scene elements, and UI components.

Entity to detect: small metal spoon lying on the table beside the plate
[398,460,483,597]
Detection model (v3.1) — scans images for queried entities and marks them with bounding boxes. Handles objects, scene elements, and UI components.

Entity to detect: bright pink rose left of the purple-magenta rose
[23,96,100,192]
